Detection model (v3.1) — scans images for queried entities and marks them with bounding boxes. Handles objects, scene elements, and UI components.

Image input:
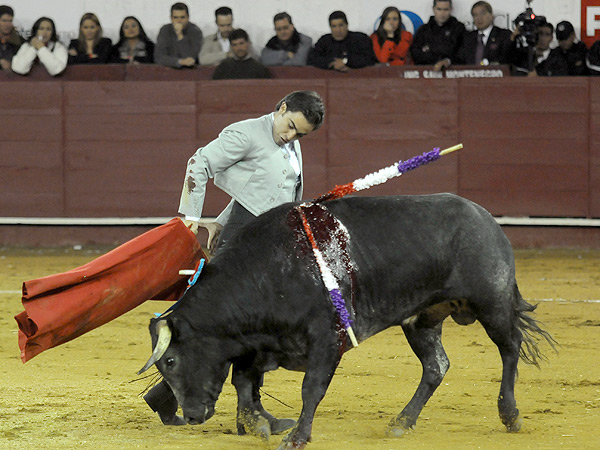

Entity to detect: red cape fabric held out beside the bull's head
[15,219,205,363]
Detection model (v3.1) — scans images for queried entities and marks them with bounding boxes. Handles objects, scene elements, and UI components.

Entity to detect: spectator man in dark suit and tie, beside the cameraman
[457,1,511,66]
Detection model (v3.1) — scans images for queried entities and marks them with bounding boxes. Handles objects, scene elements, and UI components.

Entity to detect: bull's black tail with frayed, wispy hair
[513,284,558,367]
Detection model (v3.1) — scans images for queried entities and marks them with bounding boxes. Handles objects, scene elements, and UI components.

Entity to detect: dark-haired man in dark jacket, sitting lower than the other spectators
[213,28,271,80]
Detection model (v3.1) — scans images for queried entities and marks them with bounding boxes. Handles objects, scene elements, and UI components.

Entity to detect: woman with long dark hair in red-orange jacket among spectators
[371,6,412,66]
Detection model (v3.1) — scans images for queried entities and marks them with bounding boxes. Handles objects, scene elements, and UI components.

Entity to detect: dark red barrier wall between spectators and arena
[0,65,600,243]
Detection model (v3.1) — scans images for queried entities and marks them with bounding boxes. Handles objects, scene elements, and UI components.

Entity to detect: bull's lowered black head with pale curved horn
[138,315,230,425]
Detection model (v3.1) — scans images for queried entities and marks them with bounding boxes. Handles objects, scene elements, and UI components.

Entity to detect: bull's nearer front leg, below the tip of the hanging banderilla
[277,342,340,450]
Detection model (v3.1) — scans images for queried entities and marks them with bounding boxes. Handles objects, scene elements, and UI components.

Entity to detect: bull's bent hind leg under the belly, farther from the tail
[387,320,450,436]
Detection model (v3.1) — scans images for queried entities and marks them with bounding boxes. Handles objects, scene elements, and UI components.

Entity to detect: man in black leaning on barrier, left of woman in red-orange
[308,11,377,72]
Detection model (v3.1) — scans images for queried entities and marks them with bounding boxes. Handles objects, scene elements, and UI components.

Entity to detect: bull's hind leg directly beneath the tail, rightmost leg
[477,305,523,432]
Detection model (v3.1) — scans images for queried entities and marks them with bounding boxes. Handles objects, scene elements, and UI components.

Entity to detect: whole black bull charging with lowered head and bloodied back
[143,194,553,449]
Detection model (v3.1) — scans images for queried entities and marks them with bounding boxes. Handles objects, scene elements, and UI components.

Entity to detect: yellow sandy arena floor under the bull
[0,248,600,450]
